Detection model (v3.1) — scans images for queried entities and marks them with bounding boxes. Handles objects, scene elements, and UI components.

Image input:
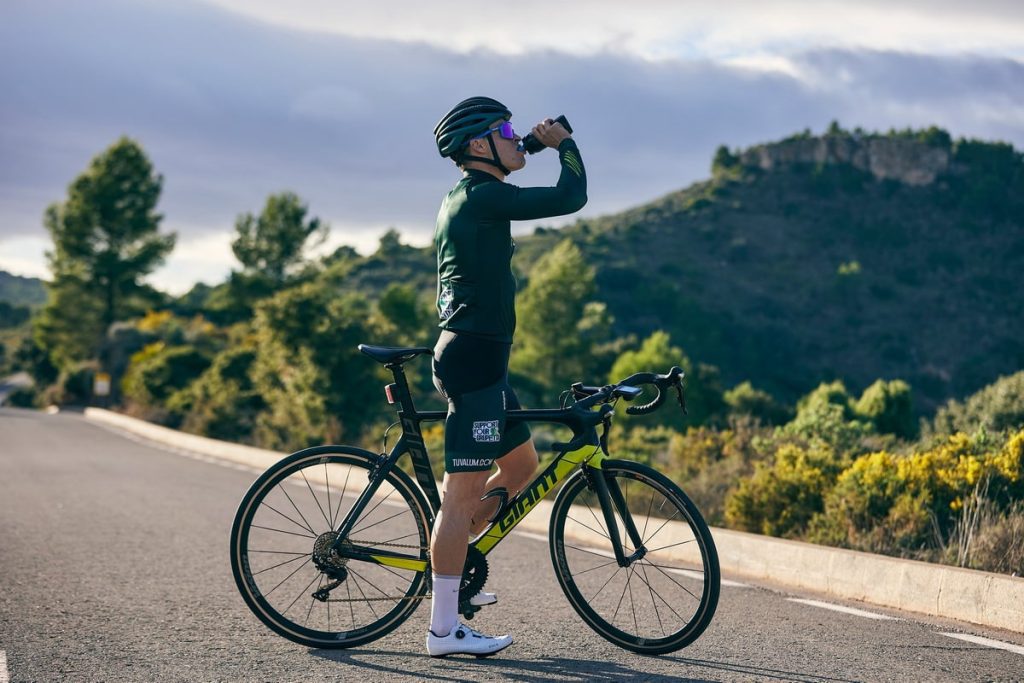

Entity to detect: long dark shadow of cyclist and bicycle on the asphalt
[309,649,846,683]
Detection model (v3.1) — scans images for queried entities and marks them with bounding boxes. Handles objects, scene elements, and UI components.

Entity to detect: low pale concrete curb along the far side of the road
[85,408,1024,633]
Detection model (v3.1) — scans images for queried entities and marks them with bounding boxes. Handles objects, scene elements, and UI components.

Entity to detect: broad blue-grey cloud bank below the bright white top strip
[0,0,1024,290]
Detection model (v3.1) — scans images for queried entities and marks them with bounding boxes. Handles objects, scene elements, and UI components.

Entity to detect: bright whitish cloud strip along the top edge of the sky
[199,0,1024,59]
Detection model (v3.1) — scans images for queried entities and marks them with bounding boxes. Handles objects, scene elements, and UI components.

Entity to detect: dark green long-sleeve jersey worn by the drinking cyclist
[434,138,587,343]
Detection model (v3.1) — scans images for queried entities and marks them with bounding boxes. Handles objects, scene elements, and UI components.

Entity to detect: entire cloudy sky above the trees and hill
[0,0,1024,294]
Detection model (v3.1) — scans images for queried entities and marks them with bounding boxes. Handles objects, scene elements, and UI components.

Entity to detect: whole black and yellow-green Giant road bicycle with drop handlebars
[230,345,721,654]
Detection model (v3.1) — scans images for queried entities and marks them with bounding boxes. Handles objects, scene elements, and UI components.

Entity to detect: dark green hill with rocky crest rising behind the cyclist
[218,124,1024,413]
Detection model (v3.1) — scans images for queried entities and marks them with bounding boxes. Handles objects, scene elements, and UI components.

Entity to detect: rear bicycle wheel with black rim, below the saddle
[230,445,433,648]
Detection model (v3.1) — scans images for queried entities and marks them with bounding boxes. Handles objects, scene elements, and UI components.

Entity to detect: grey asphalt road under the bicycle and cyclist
[0,409,1024,683]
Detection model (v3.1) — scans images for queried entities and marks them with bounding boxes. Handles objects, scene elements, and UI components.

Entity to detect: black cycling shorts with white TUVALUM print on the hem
[432,330,529,473]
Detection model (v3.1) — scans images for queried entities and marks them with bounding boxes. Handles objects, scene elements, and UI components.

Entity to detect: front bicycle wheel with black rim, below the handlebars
[550,460,721,654]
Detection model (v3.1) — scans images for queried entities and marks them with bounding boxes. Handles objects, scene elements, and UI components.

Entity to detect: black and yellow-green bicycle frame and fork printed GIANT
[333,364,646,571]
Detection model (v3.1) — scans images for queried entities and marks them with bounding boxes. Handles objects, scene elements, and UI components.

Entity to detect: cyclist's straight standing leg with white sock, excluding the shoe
[430,470,489,636]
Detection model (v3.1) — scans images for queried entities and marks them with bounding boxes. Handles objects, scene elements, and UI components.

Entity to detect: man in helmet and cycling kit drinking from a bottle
[427,97,587,656]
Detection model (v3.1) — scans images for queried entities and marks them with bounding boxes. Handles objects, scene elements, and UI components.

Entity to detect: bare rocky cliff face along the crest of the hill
[740,135,951,185]
